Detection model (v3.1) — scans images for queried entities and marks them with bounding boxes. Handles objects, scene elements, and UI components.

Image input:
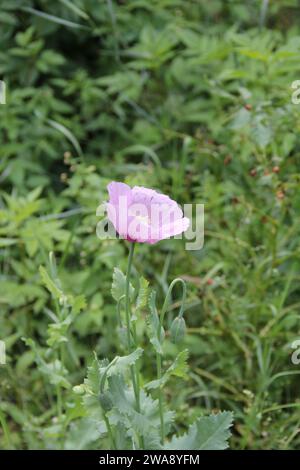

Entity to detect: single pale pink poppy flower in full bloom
[106,181,190,244]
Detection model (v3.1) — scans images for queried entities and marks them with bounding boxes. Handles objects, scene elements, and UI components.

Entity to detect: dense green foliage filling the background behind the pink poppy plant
[0,0,300,449]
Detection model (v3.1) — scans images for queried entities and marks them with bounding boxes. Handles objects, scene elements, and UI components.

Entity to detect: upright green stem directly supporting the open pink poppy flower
[125,243,144,449]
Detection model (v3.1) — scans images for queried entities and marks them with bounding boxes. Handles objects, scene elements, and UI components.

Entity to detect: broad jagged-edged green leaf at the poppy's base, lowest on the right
[165,411,233,450]
